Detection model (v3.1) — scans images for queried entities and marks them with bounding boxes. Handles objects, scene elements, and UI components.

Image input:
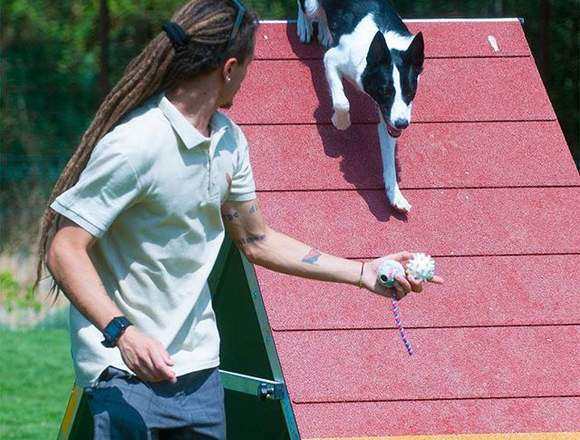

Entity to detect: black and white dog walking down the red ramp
[298,0,425,212]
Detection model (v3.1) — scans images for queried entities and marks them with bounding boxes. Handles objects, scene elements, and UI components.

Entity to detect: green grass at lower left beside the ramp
[0,329,74,440]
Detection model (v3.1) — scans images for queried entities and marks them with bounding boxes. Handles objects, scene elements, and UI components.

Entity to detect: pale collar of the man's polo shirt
[158,93,227,150]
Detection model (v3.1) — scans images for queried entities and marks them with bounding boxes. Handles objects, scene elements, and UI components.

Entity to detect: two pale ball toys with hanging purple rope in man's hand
[378,253,435,356]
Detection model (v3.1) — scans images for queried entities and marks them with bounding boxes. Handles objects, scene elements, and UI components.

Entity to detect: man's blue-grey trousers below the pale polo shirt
[85,367,226,440]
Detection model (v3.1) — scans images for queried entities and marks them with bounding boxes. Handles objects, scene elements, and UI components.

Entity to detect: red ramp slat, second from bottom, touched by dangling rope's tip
[274,326,580,403]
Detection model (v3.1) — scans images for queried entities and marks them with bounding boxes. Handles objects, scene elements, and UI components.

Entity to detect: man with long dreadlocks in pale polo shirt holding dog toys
[38,0,440,440]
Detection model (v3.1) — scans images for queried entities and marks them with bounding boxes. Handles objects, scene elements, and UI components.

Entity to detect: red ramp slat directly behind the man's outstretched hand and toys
[257,255,580,331]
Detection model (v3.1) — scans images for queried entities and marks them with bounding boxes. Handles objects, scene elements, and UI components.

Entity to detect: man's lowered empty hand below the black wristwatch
[117,325,177,383]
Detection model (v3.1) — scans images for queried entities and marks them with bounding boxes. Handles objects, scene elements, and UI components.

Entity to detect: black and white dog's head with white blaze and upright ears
[361,32,425,137]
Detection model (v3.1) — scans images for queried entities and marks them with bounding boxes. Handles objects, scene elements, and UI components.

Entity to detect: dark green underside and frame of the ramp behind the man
[58,238,300,440]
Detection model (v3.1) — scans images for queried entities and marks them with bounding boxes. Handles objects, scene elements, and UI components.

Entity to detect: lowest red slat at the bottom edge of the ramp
[294,398,580,440]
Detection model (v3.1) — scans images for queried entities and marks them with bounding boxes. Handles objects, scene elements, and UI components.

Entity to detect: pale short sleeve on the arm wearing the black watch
[50,135,140,238]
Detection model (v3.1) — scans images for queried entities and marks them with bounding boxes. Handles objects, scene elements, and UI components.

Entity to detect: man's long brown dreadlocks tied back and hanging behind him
[34,0,258,300]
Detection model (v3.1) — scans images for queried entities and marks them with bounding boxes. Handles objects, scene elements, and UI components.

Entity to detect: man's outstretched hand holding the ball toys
[362,252,443,299]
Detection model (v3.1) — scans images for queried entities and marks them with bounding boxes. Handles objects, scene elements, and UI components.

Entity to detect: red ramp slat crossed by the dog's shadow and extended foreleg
[244,121,580,191]
